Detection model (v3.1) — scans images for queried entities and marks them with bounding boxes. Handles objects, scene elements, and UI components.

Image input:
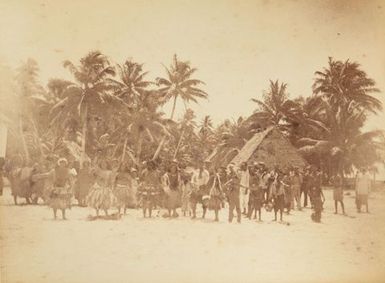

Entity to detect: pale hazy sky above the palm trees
[0,0,385,128]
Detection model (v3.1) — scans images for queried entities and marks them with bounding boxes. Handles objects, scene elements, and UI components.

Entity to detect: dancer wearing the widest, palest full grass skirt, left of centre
[86,160,117,219]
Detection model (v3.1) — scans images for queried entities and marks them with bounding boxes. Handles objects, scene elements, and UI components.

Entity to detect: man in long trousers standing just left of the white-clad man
[227,164,240,223]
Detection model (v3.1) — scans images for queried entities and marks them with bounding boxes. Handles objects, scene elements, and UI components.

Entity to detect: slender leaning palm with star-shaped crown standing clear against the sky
[153,55,208,159]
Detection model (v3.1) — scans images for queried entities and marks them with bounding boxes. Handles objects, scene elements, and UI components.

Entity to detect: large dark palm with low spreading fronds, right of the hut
[299,58,382,175]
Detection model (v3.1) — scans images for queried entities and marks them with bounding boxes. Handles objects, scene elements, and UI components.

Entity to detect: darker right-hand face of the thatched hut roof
[249,130,306,170]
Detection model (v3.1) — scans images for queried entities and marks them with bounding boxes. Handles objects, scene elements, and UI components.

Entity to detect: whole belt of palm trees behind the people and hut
[4,51,383,174]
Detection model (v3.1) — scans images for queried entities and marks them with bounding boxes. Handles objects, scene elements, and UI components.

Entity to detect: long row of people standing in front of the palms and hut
[0,155,370,223]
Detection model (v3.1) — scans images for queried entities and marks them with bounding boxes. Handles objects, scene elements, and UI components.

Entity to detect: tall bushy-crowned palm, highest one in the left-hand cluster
[51,51,122,160]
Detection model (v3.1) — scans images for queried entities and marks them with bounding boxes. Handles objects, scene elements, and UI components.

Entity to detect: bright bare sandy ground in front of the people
[0,188,385,283]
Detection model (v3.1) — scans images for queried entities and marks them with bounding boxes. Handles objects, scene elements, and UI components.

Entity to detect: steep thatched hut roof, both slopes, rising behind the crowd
[231,127,307,170]
